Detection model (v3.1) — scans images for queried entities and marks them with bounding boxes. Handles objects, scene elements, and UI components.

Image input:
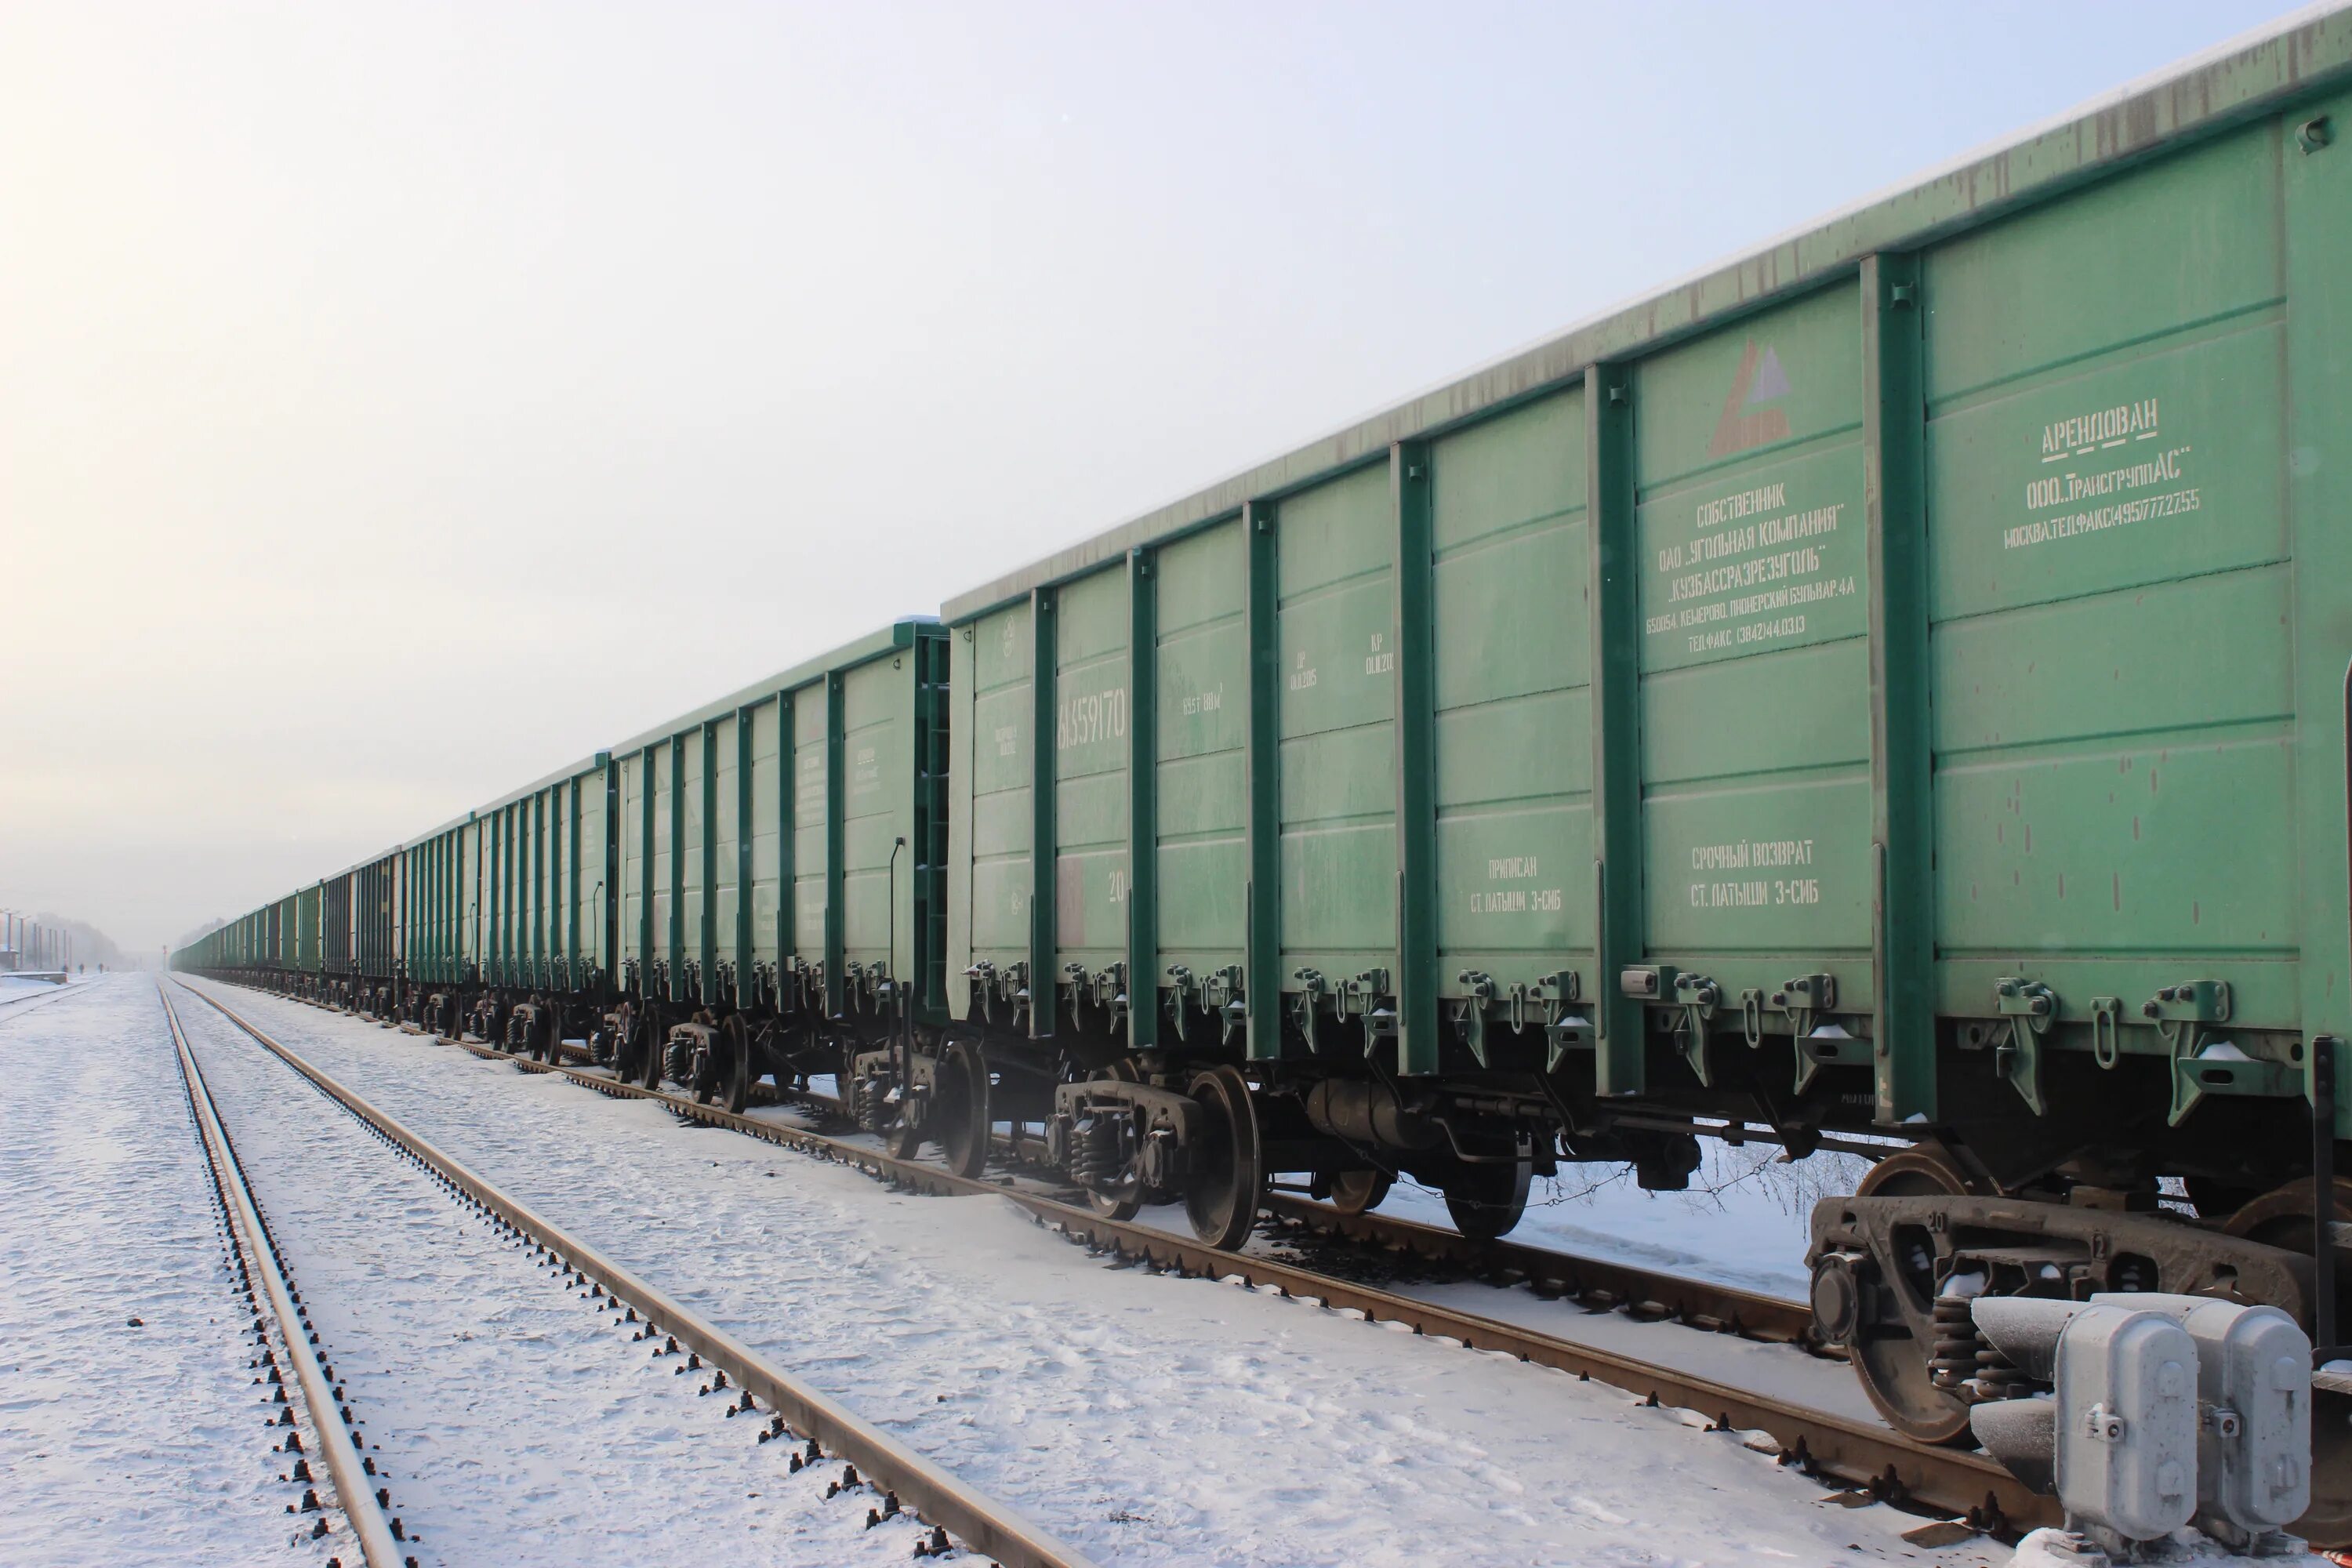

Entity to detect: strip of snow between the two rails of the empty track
[181,982,946,1568]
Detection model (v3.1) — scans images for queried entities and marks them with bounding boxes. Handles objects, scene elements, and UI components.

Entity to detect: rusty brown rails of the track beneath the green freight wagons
[248,992,2058,1535]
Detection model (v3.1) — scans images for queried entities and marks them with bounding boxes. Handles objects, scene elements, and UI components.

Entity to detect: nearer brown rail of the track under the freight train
[318,1004,2060,1533]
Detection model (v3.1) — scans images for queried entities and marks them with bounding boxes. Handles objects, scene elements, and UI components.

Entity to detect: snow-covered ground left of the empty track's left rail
[0,975,301,1568]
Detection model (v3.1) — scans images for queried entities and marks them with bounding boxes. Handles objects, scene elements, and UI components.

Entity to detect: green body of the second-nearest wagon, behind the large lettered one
[609,619,948,1022]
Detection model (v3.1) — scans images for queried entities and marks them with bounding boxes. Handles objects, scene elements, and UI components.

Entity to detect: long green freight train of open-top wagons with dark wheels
[176,12,2352,1535]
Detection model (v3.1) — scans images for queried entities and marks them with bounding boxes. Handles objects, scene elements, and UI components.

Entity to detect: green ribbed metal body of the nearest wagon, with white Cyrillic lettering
[943,14,2352,1161]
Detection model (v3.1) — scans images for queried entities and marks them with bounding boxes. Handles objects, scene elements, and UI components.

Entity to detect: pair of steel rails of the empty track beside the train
[165,987,1091,1568]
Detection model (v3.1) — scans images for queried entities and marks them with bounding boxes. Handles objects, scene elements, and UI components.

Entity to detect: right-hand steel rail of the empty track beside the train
[183,982,1094,1568]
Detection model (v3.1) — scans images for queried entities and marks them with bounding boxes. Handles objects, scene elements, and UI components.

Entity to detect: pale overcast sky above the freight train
[0,0,2281,947]
